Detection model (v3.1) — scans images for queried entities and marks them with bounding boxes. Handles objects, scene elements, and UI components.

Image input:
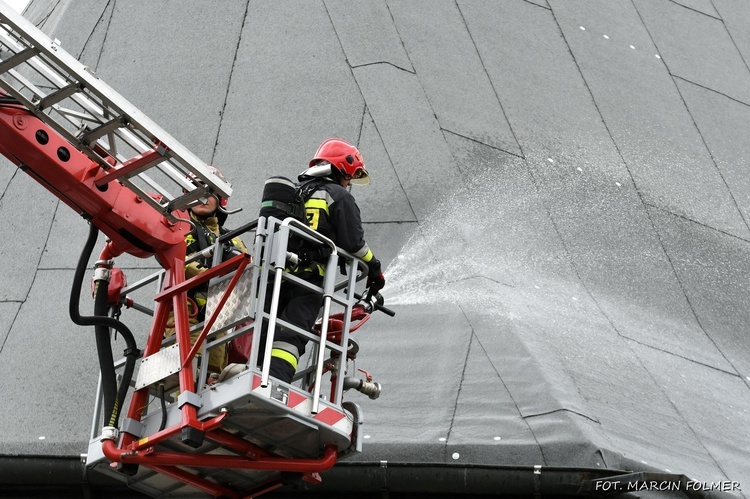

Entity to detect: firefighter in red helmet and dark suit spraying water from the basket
[270,138,385,382]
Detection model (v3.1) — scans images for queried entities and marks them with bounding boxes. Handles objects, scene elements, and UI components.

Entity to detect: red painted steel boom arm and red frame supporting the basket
[0,92,356,497]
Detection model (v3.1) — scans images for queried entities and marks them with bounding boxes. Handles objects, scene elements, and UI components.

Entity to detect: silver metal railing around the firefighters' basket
[91,217,366,439]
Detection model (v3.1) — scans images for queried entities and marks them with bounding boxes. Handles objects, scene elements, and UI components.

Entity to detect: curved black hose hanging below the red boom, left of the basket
[69,224,140,426]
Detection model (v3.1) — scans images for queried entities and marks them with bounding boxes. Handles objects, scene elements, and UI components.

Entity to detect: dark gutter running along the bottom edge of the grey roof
[0,454,738,499]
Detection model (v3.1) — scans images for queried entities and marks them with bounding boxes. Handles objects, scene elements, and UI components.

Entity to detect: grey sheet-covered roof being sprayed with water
[0,0,750,497]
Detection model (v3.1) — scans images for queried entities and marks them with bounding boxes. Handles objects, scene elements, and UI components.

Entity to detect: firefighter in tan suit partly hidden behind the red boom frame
[165,166,247,382]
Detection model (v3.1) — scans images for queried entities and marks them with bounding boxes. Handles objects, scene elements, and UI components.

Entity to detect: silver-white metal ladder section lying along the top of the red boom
[0,0,231,221]
